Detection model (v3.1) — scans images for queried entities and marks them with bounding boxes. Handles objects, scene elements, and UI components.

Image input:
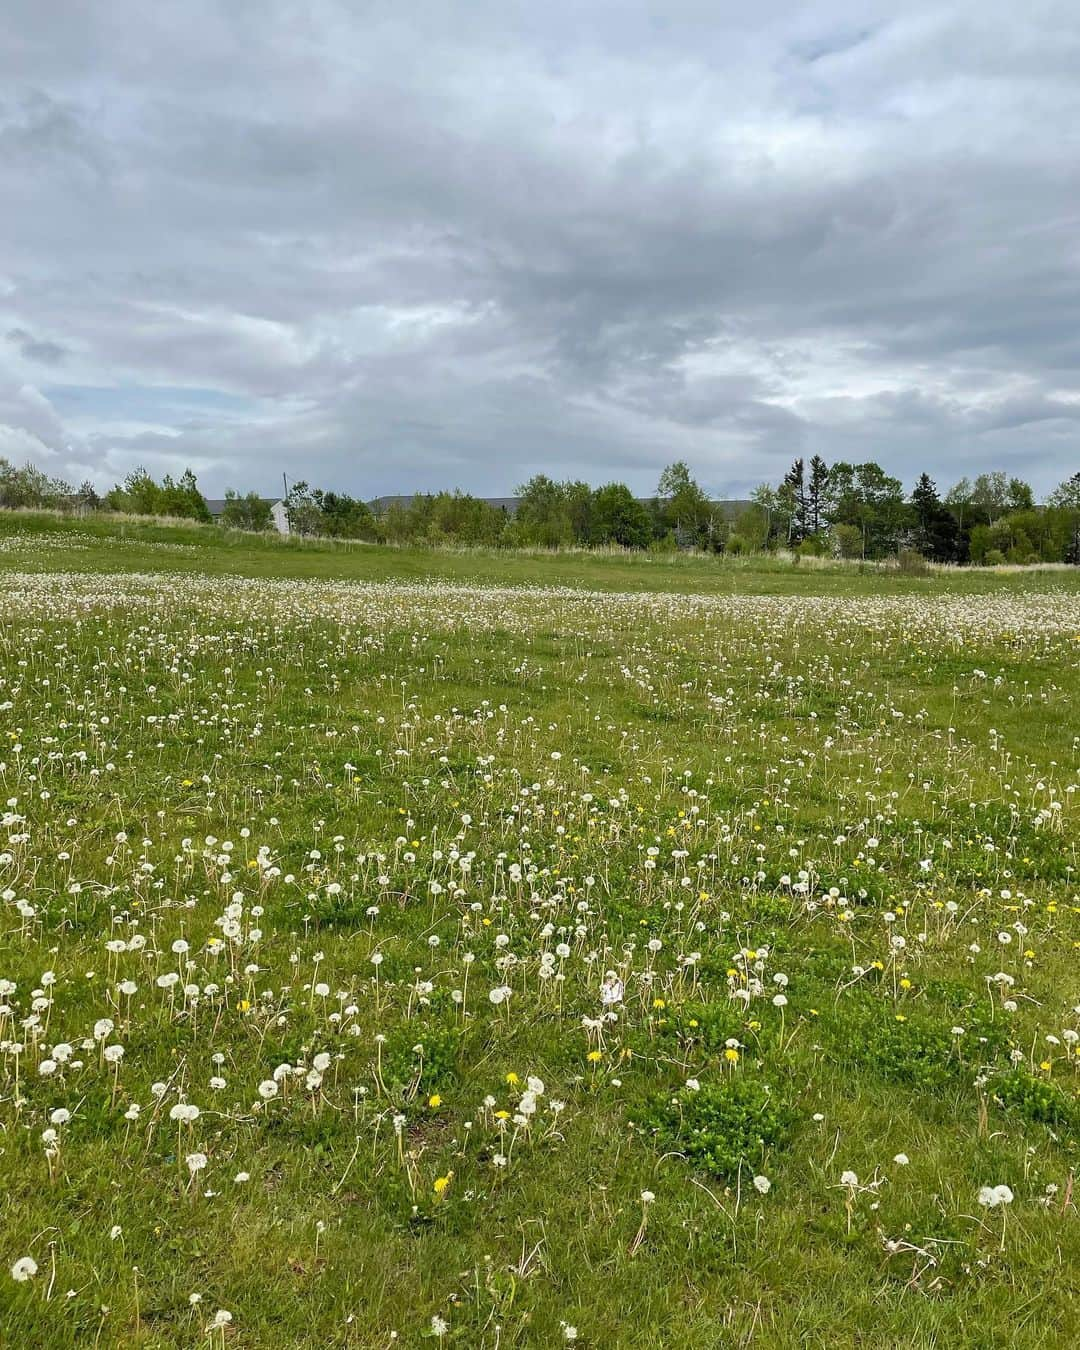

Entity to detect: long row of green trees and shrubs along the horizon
[0,455,1080,564]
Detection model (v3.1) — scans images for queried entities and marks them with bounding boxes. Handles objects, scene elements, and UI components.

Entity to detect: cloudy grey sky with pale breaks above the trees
[0,0,1080,498]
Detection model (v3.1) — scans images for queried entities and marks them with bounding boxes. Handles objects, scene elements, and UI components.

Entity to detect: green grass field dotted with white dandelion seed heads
[0,517,1080,1350]
